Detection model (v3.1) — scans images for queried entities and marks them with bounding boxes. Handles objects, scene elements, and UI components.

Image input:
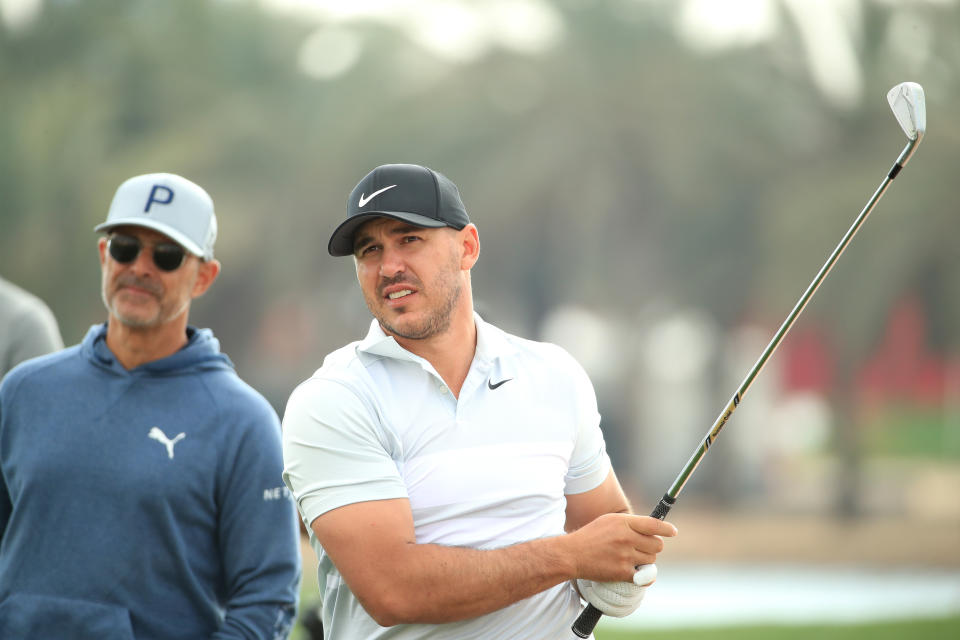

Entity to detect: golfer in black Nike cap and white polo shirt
[283,164,676,640]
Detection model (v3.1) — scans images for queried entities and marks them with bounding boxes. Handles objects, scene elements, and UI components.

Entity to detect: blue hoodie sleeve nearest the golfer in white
[213,396,300,640]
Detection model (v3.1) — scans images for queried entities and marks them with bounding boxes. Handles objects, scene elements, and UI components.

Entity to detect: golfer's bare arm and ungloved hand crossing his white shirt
[311,492,676,626]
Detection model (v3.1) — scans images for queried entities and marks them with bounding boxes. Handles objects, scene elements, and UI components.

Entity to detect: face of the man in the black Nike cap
[353,218,464,340]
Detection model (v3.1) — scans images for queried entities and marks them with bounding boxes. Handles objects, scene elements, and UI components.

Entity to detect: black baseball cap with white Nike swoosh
[327,164,470,256]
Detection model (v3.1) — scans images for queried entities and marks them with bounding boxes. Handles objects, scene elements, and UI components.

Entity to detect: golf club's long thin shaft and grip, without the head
[572,139,919,638]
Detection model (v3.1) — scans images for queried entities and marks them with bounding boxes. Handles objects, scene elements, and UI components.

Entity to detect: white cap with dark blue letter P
[93,173,217,260]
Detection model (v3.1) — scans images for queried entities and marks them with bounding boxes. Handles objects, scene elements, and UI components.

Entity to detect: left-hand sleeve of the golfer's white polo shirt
[283,378,408,528]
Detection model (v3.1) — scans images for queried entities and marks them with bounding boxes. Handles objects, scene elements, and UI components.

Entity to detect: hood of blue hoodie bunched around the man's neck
[80,322,234,375]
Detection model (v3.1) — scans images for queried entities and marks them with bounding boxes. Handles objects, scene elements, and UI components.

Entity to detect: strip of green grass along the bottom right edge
[595,616,960,640]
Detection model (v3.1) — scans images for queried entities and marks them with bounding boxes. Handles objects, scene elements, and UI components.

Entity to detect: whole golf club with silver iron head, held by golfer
[571,82,927,638]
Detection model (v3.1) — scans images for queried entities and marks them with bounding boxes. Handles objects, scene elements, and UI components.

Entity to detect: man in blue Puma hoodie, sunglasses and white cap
[0,174,300,640]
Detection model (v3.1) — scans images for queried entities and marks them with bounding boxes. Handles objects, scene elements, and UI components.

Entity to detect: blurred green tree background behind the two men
[0,0,960,533]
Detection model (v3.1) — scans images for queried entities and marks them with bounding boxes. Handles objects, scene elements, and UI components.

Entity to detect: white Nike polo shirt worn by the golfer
[283,315,610,640]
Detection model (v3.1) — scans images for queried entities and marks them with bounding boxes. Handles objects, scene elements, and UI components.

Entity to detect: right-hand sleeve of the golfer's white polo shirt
[563,356,610,495]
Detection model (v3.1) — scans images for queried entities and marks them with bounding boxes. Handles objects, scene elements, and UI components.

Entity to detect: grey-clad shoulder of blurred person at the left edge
[0,278,63,378]
